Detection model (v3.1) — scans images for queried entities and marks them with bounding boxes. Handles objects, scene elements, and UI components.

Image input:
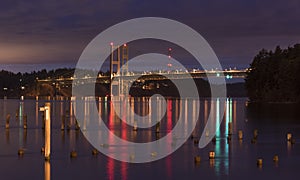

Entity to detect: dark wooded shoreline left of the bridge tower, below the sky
[0,68,110,98]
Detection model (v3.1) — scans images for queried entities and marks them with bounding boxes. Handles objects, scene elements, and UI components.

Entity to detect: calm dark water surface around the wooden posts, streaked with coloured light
[0,98,300,179]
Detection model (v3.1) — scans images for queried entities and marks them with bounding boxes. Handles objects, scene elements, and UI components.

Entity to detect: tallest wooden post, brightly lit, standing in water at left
[40,103,51,160]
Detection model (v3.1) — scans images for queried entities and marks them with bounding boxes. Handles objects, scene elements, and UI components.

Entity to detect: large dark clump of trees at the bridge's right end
[246,44,300,102]
